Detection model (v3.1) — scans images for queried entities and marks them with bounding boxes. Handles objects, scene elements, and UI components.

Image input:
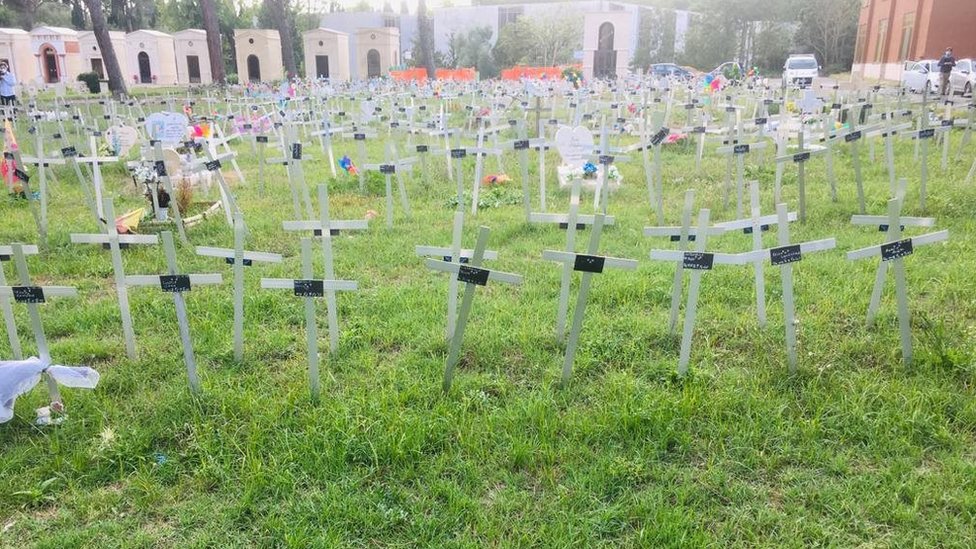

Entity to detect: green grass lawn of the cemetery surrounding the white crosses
[0,110,976,547]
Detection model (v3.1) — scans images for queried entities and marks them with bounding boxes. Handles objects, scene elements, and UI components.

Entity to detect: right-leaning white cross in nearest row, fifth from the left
[542,214,637,387]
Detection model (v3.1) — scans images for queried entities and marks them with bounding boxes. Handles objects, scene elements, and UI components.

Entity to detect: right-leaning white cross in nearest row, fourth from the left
[424,227,522,392]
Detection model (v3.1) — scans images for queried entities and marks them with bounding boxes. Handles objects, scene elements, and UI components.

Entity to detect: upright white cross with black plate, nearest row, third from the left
[261,237,358,401]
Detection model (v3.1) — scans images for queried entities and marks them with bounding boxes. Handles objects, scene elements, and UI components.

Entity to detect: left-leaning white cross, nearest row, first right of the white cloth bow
[125,231,223,393]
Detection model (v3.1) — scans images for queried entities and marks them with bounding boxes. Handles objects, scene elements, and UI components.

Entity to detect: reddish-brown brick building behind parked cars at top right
[851,0,976,80]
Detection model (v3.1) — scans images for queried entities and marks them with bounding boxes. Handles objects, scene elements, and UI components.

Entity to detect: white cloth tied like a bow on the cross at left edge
[0,357,99,425]
